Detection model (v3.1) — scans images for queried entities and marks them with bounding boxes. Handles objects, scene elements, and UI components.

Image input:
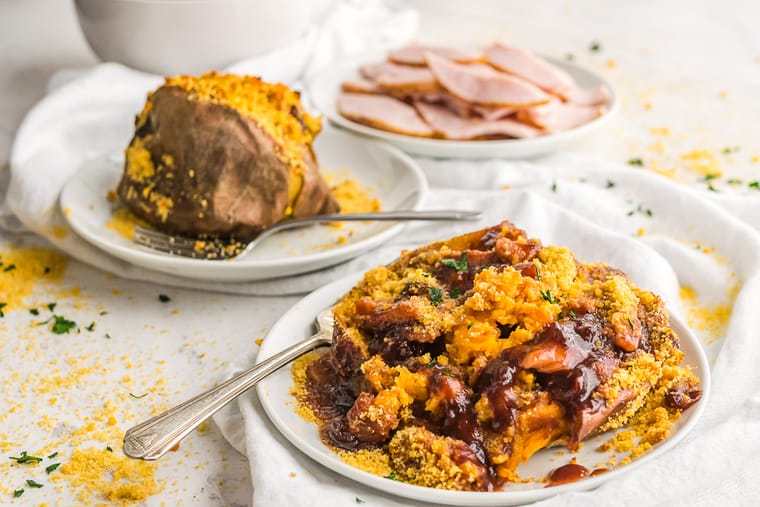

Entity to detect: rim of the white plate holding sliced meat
[305,52,620,158]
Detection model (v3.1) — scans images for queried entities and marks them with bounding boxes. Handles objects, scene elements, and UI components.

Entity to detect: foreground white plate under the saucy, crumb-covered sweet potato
[258,274,710,506]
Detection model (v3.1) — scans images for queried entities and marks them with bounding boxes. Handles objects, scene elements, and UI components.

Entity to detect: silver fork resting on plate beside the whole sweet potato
[132,210,482,260]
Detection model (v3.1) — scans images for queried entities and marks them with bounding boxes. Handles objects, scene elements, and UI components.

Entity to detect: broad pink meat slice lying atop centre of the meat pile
[425,53,550,108]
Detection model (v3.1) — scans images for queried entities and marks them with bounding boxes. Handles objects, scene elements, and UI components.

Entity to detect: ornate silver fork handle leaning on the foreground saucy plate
[124,331,331,460]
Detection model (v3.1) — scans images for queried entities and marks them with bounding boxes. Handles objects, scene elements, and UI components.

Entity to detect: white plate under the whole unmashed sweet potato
[60,129,428,281]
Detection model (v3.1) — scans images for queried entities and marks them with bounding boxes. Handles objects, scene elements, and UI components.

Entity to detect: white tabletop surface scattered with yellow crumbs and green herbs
[0,0,760,505]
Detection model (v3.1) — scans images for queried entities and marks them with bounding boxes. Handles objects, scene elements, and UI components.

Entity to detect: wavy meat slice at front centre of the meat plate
[414,102,541,140]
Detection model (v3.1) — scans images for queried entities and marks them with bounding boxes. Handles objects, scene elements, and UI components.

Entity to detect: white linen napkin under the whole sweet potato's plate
[0,0,418,295]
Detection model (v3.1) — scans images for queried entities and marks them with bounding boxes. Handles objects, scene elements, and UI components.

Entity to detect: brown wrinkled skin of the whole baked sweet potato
[117,86,338,240]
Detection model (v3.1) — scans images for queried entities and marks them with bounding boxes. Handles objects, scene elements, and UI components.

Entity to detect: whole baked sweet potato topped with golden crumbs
[118,73,338,240]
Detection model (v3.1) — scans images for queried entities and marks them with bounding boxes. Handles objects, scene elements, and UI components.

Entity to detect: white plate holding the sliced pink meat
[307,54,618,158]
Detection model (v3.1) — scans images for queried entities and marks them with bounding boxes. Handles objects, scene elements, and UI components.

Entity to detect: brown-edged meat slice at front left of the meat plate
[338,93,433,137]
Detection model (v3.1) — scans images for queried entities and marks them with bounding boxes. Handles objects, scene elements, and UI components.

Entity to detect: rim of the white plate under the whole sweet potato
[58,127,429,281]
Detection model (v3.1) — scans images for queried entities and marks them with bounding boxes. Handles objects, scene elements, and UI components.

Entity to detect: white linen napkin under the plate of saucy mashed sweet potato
[215,155,760,506]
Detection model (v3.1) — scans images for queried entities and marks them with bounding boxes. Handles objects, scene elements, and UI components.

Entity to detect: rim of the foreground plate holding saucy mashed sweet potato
[256,272,711,507]
